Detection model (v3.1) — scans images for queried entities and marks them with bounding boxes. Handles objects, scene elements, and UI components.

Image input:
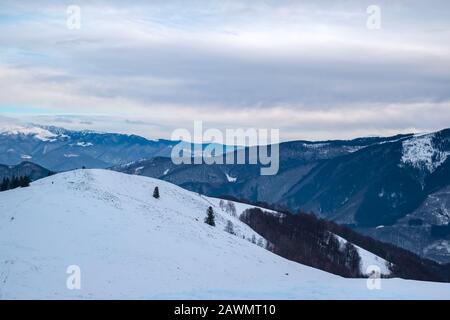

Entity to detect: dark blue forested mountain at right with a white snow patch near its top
[113,129,450,262]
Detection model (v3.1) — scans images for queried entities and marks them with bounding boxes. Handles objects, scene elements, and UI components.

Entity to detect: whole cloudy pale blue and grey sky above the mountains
[0,0,450,140]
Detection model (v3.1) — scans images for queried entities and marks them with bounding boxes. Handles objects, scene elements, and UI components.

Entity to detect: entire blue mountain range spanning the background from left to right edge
[0,122,450,262]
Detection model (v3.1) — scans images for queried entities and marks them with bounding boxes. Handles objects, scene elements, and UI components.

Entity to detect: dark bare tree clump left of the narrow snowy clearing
[240,208,363,278]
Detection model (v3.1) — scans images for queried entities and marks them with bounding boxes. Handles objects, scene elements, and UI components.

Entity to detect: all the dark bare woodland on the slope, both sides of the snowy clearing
[241,206,450,282]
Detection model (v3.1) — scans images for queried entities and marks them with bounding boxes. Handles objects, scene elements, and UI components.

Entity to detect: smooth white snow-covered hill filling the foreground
[0,170,450,299]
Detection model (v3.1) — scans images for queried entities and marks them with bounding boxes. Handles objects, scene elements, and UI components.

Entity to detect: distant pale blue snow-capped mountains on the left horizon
[0,125,176,171]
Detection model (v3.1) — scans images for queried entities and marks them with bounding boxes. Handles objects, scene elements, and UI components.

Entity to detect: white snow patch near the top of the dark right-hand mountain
[401,134,450,173]
